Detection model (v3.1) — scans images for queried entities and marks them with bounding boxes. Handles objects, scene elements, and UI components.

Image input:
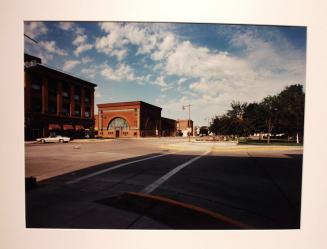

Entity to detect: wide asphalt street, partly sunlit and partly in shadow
[25,139,302,229]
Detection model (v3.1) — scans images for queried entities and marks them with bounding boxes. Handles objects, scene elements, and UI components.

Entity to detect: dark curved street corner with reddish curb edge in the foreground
[97,192,250,229]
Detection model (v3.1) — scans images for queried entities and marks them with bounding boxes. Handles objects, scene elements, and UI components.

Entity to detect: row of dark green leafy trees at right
[209,84,305,143]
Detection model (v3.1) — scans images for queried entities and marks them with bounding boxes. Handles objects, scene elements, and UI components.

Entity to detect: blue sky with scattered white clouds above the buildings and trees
[24,22,306,125]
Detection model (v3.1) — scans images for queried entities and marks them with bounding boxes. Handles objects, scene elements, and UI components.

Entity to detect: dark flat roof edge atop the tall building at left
[25,63,97,87]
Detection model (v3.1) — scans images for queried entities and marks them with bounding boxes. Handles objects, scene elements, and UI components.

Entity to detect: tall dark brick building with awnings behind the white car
[24,54,96,140]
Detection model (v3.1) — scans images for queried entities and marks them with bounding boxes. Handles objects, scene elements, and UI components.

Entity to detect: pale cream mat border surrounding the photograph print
[0,0,327,249]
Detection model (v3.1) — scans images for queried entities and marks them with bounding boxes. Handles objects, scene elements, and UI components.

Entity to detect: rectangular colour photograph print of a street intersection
[22,21,307,230]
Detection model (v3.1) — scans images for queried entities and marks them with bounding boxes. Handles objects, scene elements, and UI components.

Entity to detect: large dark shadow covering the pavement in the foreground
[26,154,302,229]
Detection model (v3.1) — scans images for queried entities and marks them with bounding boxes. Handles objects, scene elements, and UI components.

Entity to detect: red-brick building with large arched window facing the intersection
[95,101,176,138]
